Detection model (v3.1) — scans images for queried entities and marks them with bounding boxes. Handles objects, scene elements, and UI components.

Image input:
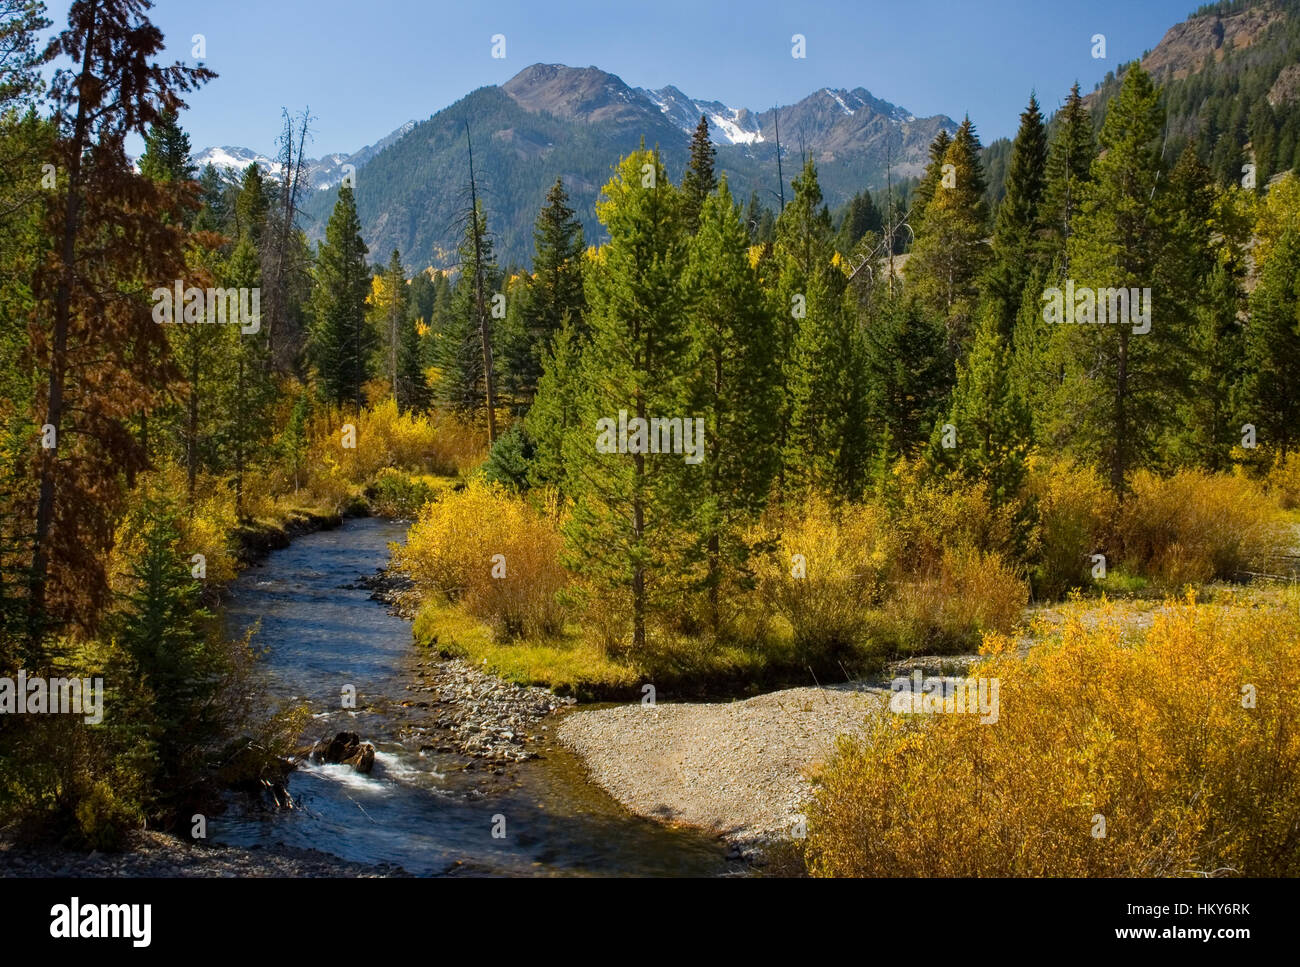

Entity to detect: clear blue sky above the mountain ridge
[47,0,1200,155]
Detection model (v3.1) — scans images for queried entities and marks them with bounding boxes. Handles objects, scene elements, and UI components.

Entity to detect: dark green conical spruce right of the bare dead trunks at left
[311,183,377,412]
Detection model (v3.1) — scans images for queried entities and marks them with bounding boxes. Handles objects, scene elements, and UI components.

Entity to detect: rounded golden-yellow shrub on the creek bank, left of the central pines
[393,478,568,636]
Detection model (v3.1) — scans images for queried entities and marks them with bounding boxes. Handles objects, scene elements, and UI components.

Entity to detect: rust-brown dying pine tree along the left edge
[29,0,213,634]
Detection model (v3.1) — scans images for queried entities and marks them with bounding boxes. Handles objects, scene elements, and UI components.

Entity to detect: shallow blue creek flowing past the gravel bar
[208,519,728,876]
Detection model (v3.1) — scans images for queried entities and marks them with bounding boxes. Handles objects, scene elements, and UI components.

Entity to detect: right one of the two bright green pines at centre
[685,177,780,639]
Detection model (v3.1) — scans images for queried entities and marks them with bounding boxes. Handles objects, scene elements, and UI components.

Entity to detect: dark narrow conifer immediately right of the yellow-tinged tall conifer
[985,95,1048,339]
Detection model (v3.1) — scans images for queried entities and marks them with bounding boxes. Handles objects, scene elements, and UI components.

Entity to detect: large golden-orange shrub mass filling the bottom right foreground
[805,599,1300,876]
